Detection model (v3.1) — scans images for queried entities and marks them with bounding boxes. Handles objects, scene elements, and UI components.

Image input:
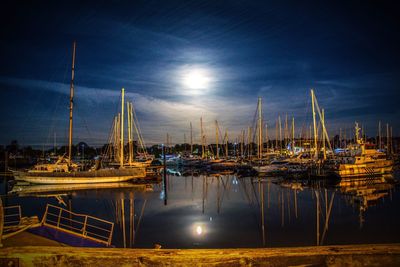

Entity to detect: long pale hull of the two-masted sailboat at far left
[13,168,146,184]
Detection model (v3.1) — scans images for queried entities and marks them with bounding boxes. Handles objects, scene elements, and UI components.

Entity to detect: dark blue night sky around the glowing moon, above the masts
[0,0,400,147]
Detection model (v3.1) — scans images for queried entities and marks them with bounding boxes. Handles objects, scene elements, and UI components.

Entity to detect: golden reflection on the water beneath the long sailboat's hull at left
[9,182,152,196]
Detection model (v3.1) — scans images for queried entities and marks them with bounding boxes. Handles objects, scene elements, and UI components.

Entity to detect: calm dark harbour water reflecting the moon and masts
[1,173,400,248]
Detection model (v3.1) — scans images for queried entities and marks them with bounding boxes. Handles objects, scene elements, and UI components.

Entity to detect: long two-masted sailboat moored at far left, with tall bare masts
[11,42,146,184]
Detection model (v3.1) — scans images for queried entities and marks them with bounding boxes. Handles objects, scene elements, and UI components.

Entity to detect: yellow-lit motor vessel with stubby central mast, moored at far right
[335,123,393,178]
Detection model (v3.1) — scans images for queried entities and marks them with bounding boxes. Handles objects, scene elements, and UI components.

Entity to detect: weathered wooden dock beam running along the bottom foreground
[0,244,400,266]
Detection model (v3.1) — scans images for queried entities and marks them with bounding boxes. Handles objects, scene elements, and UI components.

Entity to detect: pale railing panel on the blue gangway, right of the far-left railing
[42,204,114,246]
